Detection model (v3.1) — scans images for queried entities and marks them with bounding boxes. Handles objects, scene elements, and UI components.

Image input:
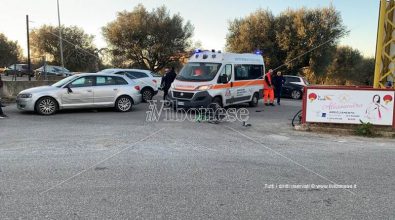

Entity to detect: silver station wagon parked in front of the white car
[16,73,142,115]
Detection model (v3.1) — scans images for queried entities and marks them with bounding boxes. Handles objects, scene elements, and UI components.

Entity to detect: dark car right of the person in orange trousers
[281,75,309,99]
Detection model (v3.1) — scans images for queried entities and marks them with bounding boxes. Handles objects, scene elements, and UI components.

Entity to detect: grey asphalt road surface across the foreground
[0,95,395,219]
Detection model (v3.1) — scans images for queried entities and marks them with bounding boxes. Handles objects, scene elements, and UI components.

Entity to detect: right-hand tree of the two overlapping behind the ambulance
[276,7,347,76]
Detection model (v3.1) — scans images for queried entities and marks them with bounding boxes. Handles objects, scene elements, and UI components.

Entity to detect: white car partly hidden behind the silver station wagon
[98,69,162,102]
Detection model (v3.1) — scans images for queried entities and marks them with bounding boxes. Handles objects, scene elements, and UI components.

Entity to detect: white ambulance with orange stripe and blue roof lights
[167,51,265,108]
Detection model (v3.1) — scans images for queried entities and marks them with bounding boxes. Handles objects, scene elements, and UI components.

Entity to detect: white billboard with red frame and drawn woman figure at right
[304,87,395,126]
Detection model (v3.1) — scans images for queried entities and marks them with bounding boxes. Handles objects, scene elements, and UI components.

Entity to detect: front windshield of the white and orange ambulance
[177,63,221,81]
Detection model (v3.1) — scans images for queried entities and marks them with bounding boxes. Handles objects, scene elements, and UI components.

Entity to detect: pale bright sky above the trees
[0,0,379,57]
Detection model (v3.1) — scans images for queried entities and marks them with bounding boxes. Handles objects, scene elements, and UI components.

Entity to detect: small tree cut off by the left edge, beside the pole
[0,33,22,67]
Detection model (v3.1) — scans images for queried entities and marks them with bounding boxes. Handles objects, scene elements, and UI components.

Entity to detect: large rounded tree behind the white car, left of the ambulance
[103,5,193,71]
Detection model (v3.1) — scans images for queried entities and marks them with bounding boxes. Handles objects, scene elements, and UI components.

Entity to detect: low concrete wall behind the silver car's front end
[0,80,58,99]
